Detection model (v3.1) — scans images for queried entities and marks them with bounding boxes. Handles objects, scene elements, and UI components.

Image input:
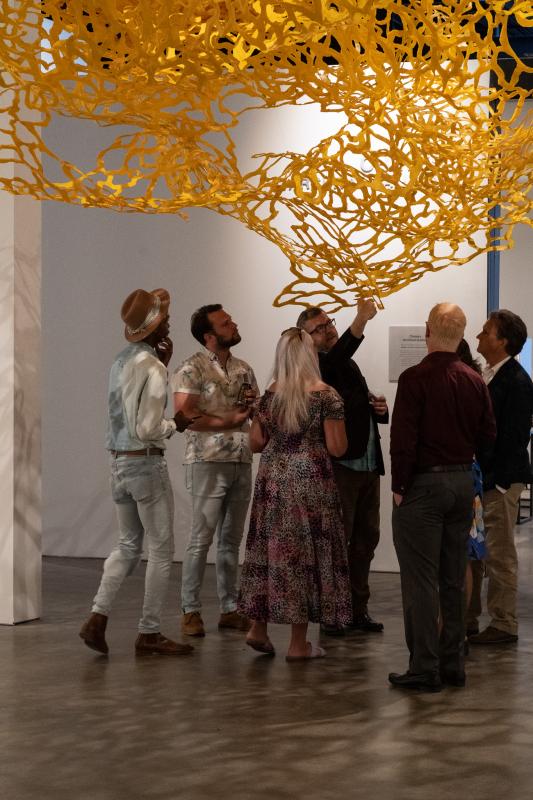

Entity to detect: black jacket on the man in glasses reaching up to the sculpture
[318,328,389,475]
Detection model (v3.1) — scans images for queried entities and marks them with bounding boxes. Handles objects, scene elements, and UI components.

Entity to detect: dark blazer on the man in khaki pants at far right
[478,358,533,489]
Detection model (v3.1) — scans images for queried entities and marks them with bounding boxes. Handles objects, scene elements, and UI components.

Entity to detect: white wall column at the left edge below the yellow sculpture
[0,188,41,625]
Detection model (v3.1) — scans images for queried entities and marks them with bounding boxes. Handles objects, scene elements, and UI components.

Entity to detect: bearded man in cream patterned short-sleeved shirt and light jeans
[172,304,258,636]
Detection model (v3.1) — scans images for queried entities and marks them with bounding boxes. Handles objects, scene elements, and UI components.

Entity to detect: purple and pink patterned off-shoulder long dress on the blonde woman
[239,388,352,625]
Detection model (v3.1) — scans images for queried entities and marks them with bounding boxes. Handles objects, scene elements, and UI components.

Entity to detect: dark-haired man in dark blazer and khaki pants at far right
[467,309,533,645]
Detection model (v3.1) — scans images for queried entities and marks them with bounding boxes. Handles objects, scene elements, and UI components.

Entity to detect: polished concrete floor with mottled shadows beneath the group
[0,524,533,800]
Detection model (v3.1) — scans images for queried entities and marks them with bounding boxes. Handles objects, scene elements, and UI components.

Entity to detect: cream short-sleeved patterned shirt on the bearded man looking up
[171,350,259,464]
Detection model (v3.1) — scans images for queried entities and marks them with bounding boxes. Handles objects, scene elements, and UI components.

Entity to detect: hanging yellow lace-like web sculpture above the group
[0,0,533,310]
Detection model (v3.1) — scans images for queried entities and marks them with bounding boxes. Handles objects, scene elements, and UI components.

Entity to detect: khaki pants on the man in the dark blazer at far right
[467,483,524,635]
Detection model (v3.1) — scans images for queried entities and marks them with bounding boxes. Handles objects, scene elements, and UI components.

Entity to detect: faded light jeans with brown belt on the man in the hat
[92,456,174,633]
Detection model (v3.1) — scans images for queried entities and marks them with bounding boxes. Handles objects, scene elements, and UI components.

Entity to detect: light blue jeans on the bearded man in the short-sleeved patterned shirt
[181,461,252,613]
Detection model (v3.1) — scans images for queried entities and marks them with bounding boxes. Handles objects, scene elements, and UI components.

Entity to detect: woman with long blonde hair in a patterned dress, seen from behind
[239,328,351,661]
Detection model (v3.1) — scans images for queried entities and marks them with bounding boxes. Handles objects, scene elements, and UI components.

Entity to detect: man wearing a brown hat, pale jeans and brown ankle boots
[80,289,193,656]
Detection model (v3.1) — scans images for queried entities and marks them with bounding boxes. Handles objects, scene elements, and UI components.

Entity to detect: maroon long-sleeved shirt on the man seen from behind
[391,351,496,494]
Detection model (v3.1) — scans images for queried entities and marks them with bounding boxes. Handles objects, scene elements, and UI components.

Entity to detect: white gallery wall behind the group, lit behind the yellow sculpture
[42,98,516,570]
